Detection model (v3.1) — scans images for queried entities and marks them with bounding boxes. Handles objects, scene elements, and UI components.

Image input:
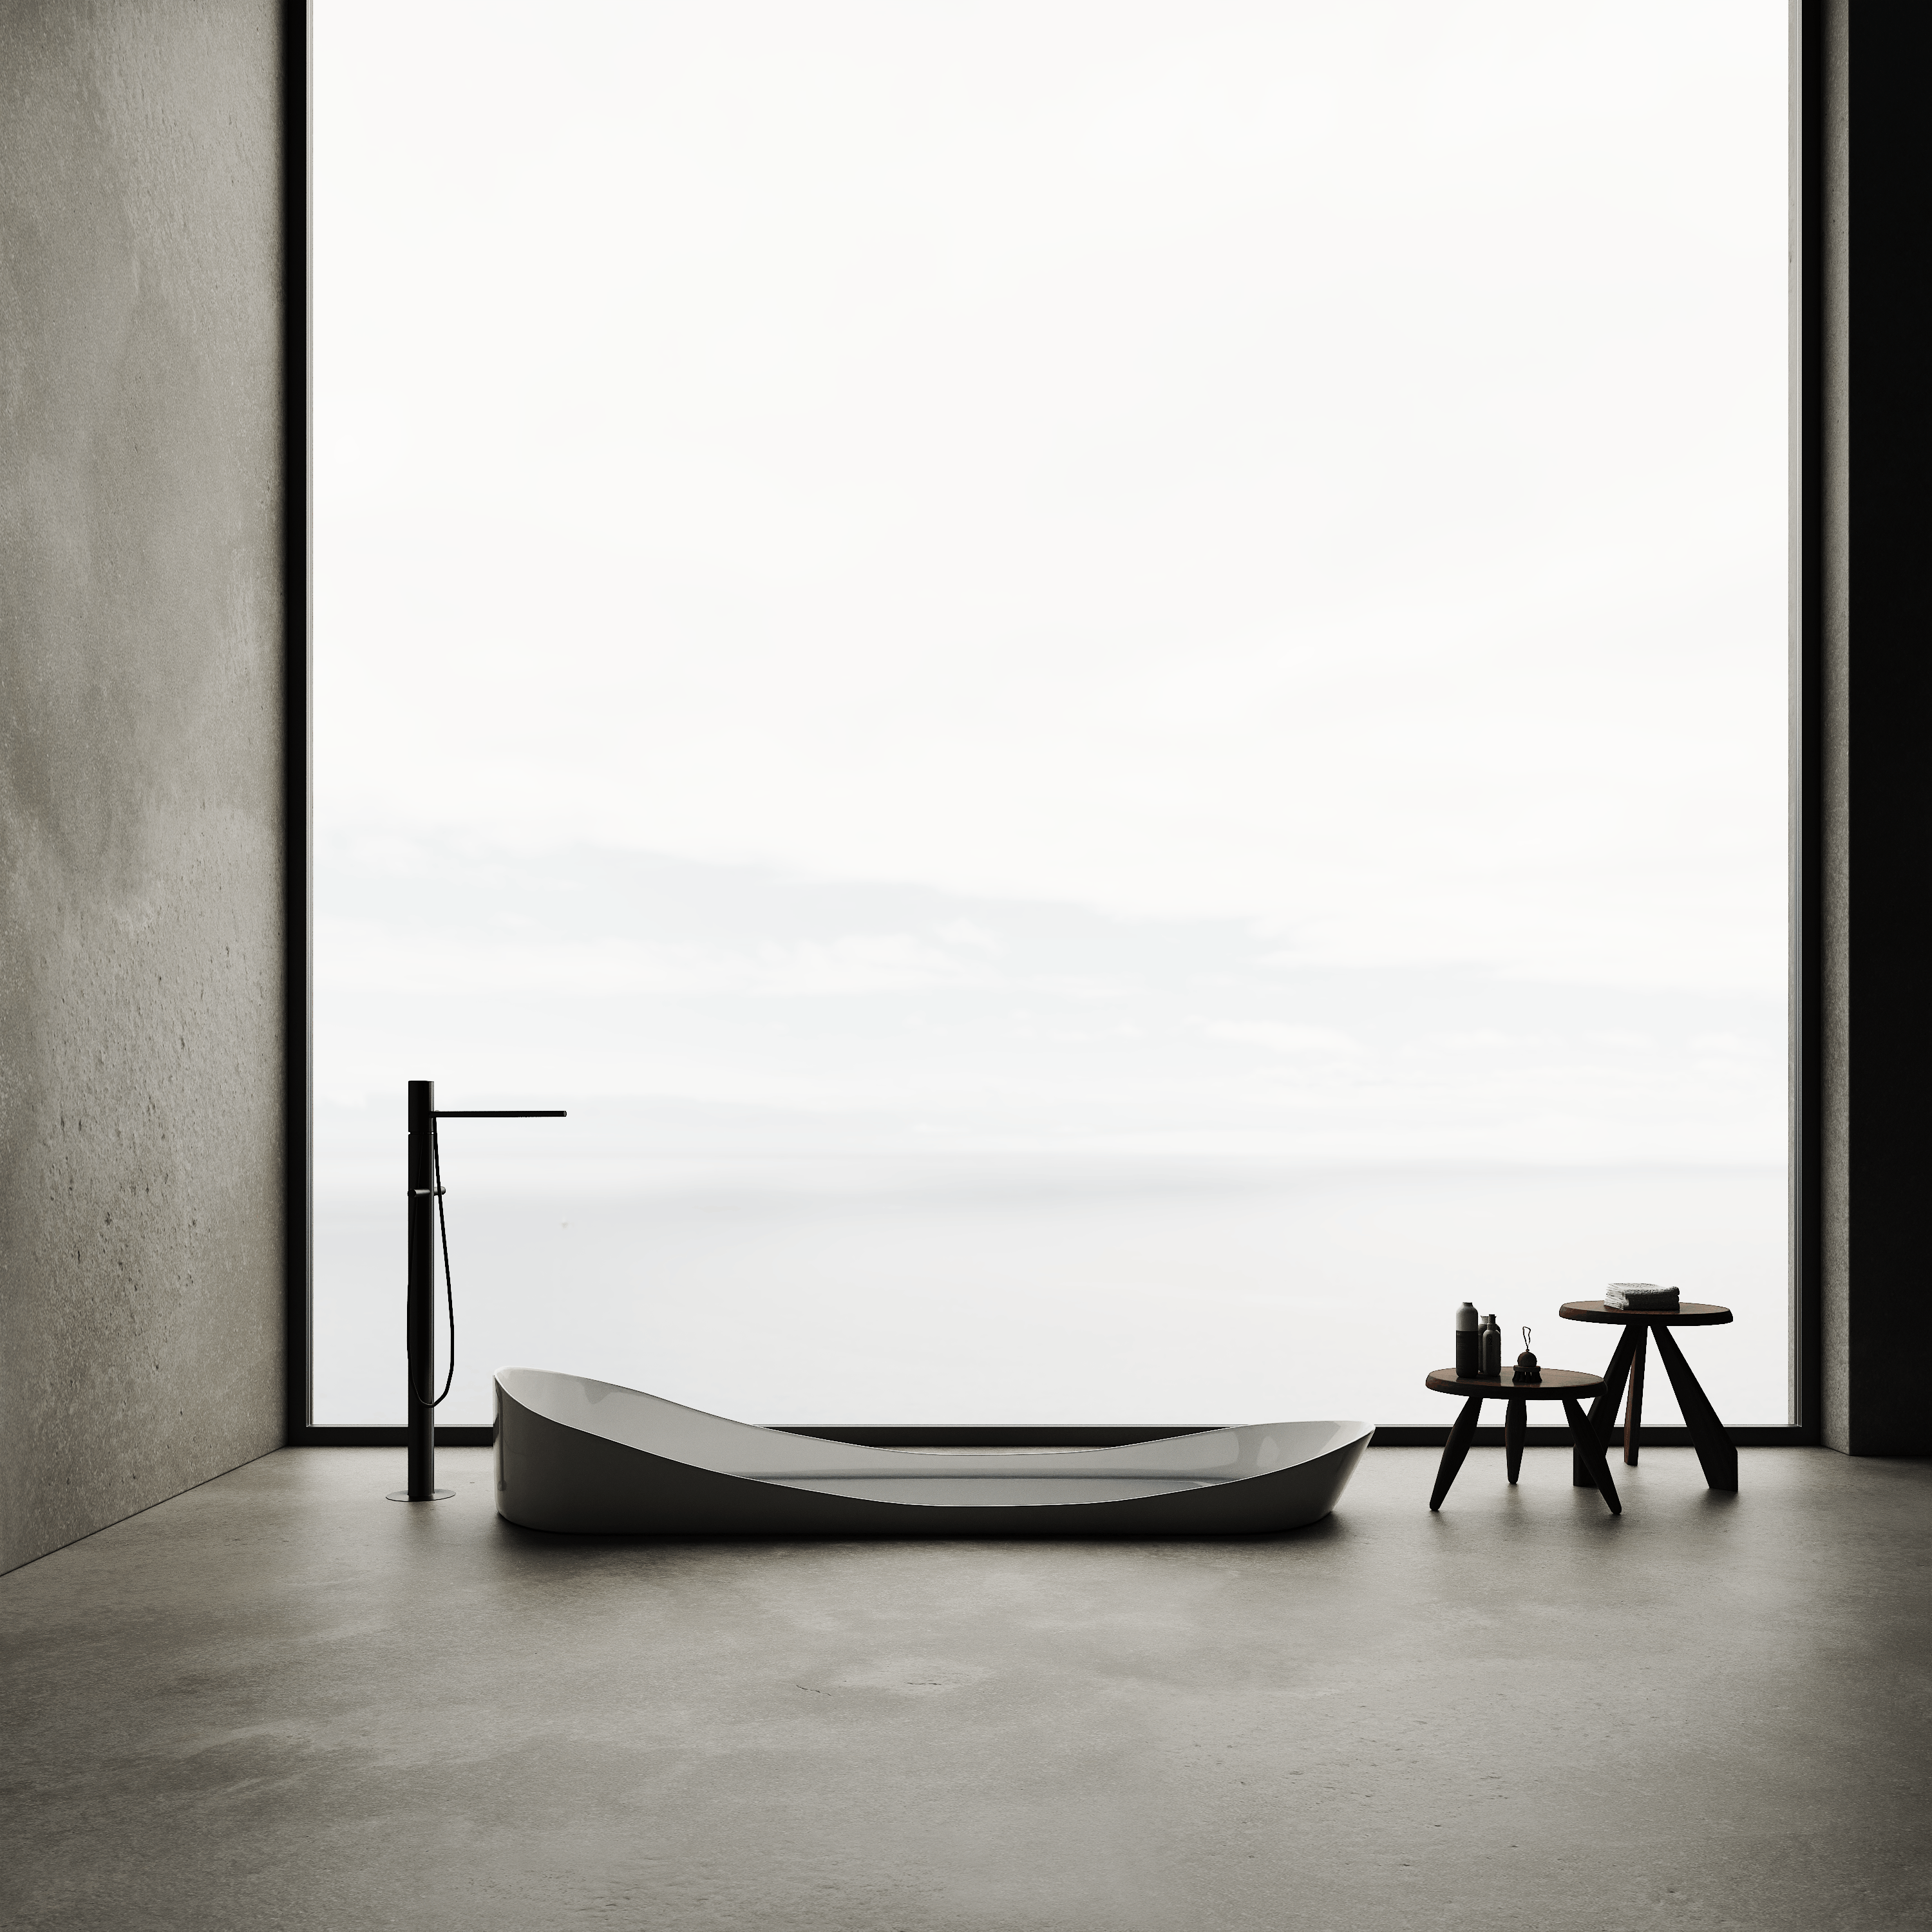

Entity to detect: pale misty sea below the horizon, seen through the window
[315,1150,1789,1424]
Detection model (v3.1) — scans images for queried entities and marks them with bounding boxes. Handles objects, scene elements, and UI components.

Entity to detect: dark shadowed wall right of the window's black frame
[1808,0,1932,1455]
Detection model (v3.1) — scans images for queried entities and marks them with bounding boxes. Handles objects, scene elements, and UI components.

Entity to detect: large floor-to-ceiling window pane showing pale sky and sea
[313,0,1787,1422]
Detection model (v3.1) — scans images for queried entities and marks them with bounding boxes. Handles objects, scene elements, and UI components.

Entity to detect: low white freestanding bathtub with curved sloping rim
[497,1368,1376,1536]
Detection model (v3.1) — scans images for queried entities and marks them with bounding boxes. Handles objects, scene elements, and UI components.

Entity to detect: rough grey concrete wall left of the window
[0,0,284,1569]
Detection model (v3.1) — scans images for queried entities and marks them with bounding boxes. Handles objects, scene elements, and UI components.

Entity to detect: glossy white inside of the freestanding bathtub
[497,1368,1372,1507]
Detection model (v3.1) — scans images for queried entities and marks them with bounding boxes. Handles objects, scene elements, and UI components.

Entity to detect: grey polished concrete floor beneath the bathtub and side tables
[0,1449,1932,1932]
